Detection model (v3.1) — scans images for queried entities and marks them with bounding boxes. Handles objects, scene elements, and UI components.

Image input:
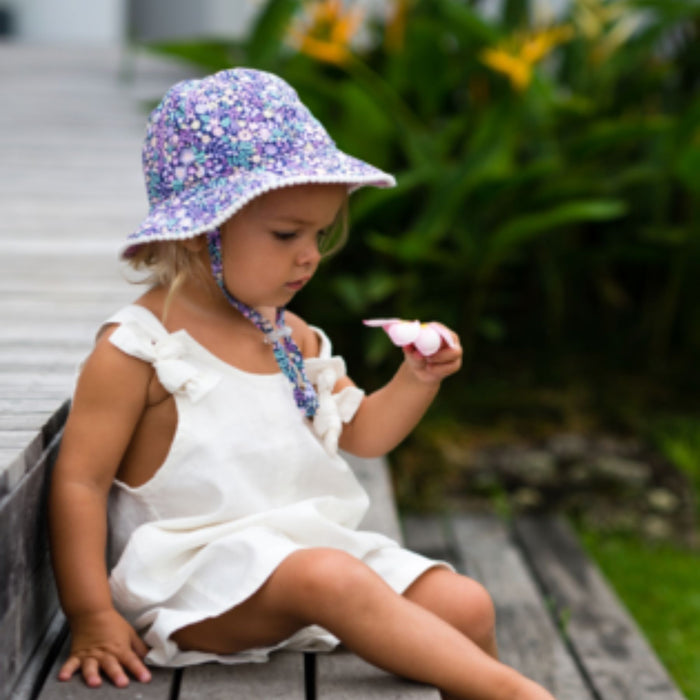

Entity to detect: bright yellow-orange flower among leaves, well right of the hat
[479,25,573,92]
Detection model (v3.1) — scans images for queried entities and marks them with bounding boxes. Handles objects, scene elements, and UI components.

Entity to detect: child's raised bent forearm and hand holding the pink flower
[335,334,462,457]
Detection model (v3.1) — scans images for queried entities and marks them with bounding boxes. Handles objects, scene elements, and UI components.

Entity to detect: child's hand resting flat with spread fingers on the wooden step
[58,610,151,688]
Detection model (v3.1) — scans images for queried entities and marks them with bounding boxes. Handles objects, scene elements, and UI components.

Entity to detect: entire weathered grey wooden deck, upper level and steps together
[0,44,682,700]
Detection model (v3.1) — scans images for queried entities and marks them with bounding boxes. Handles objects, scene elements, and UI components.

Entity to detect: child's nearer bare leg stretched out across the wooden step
[173,549,553,700]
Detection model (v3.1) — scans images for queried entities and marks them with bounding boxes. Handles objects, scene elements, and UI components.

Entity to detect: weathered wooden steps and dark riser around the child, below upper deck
[0,404,683,700]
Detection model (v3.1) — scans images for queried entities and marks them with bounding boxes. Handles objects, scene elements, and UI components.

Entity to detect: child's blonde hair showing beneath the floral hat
[127,197,349,322]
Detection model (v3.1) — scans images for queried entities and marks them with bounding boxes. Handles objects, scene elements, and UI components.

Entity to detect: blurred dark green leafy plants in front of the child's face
[145,0,700,408]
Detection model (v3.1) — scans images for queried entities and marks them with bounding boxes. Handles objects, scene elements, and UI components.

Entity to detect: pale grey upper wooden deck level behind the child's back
[0,43,198,494]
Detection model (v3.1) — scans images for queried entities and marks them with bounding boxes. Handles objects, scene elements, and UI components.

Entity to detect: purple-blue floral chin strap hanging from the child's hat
[207,229,318,418]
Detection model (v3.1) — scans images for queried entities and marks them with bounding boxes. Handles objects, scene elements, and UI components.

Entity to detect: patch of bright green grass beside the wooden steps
[581,532,700,700]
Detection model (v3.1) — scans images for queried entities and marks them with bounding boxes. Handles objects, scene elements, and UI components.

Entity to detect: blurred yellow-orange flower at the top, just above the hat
[290,0,362,65]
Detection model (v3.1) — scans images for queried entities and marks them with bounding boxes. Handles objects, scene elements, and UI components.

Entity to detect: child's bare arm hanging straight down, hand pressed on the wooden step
[50,333,152,686]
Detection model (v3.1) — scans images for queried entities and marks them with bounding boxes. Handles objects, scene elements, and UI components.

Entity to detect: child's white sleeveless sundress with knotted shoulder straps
[106,305,445,666]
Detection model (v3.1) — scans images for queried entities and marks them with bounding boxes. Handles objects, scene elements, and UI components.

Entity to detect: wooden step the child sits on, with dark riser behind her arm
[0,405,439,700]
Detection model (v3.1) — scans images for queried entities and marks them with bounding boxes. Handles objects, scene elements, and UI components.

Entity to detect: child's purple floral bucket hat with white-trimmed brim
[121,68,395,258]
